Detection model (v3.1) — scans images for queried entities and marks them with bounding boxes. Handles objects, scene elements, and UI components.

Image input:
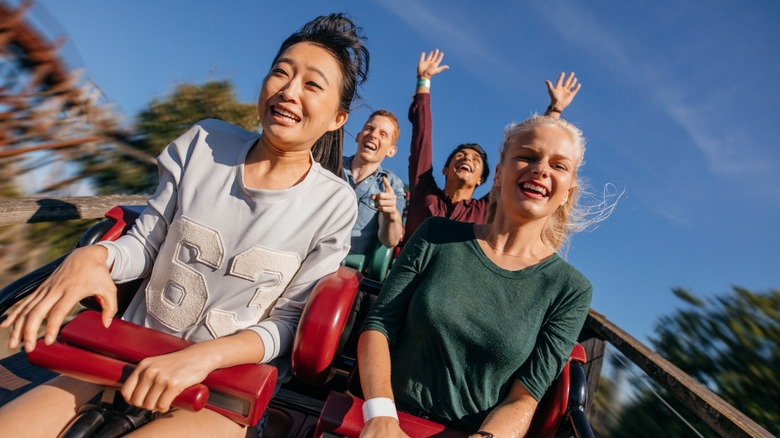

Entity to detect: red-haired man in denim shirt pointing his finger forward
[343,110,406,254]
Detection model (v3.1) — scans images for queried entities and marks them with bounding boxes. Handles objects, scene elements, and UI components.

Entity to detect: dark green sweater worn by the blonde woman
[363,217,592,430]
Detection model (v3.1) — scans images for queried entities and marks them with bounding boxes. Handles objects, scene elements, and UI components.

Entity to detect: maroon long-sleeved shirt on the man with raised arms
[404,93,490,240]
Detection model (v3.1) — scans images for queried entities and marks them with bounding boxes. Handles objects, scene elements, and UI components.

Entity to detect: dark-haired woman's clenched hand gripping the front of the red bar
[121,344,213,412]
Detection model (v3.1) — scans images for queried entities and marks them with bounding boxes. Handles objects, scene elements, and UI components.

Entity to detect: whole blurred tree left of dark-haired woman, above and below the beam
[87,81,259,194]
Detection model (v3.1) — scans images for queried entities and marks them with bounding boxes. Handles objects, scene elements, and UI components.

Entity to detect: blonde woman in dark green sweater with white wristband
[358,116,604,438]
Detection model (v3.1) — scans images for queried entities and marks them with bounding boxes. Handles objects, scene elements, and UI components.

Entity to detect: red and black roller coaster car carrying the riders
[0,207,593,438]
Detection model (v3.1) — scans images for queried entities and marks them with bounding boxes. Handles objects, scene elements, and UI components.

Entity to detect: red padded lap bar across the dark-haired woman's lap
[29,311,277,426]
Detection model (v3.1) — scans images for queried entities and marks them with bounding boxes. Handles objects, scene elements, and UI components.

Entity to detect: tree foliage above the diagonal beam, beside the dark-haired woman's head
[137,81,259,155]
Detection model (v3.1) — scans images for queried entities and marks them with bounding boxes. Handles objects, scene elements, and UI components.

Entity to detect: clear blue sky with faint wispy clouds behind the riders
[11,0,780,346]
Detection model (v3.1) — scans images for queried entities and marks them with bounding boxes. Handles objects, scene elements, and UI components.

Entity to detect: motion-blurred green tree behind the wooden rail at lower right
[610,287,780,437]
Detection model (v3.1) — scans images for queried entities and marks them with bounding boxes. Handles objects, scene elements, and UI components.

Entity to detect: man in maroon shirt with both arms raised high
[406,49,581,236]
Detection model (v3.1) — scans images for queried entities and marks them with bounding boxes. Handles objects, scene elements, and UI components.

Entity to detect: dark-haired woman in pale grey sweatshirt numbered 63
[0,14,369,436]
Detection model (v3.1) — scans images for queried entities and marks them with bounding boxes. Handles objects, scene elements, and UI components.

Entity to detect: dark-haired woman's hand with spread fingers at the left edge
[0,245,117,352]
